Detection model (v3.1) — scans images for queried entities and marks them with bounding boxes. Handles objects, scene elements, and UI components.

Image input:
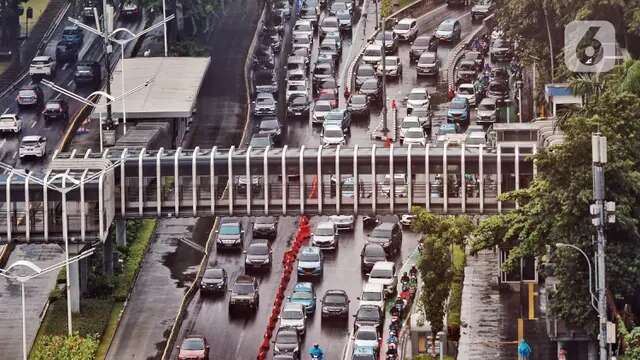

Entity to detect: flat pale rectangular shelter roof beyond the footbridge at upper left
[91,57,211,120]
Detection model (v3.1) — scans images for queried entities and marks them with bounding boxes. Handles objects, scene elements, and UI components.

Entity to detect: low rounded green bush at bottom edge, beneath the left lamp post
[30,334,98,360]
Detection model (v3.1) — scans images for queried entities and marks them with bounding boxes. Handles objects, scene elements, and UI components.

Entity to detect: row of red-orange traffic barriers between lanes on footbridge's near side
[257,215,311,360]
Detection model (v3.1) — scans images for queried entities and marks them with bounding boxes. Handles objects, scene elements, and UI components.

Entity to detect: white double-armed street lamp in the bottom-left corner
[0,248,95,360]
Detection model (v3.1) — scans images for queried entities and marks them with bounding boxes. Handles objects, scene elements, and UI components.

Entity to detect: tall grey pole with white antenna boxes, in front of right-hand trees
[589,133,616,360]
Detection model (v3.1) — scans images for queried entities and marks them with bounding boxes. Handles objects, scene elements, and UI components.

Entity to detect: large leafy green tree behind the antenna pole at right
[471,59,640,331]
